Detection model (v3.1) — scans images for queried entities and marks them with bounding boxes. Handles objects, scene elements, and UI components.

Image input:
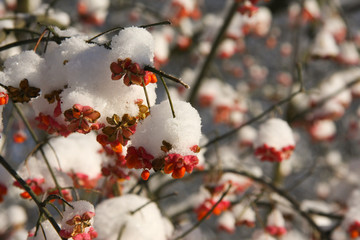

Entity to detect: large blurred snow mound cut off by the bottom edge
[94,194,167,240]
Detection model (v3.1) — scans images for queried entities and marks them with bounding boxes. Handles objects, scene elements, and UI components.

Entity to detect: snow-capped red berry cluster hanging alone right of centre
[254,118,295,162]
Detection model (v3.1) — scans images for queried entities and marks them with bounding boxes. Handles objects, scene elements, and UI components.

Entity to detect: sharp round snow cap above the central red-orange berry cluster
[131,101,201,158]
